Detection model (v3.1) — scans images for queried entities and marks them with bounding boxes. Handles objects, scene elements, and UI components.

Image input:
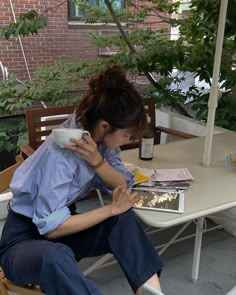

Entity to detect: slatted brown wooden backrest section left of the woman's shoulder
[25,106,76,150]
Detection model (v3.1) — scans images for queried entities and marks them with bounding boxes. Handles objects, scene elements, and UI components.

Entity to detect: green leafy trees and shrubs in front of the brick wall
[0,0,236,156]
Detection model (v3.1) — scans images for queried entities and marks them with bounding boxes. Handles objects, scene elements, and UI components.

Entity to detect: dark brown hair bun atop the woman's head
[89,65,127,95]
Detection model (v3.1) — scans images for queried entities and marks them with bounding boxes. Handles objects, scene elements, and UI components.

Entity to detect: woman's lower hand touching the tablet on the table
[111,186,141,215]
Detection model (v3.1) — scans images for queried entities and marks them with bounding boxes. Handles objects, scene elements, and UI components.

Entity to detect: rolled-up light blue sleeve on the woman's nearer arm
[32,161,73,235]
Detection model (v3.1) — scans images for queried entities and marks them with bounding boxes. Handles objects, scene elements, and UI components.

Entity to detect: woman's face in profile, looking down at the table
[103,128,131,149]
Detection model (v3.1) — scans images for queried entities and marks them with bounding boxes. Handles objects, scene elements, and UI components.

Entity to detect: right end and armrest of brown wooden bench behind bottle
[121,97,196,150]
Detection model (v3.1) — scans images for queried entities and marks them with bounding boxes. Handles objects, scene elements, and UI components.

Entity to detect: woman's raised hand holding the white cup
[65,134,102,166]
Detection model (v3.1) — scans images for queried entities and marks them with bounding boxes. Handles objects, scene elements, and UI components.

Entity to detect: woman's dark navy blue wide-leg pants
[0,210,163,295]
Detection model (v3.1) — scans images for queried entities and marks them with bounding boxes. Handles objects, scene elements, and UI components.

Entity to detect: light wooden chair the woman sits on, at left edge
[0,155,44,295]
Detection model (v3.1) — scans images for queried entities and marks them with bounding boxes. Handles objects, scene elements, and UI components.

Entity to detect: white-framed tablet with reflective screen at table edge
[132,188,184,213]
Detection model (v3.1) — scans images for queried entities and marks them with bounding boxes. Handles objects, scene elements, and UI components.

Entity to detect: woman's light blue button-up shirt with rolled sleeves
[10,114,134,235]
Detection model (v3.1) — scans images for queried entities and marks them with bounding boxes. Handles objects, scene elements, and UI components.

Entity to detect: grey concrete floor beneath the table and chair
[0,216,236,295]
